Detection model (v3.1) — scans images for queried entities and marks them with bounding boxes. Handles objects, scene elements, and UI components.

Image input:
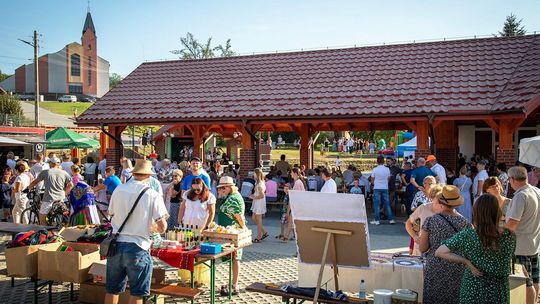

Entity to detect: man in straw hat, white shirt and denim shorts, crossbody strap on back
[105,159,169,304]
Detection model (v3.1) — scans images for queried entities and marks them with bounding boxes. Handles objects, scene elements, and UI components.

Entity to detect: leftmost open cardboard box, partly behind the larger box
[5,243,60,278]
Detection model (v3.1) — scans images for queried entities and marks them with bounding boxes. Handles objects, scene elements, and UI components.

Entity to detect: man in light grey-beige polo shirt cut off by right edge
[505,167,540,304]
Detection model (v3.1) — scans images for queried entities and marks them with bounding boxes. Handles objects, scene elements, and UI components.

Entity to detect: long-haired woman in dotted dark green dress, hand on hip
[435,194,516,304]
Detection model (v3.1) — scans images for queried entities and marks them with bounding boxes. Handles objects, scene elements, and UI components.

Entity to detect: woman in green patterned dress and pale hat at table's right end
[217,176,246,295]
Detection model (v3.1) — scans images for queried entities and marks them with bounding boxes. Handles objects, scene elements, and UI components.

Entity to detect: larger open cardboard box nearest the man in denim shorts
[38,242,100,283]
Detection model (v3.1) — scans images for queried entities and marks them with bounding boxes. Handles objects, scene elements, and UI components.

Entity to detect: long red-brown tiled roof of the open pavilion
[77,35,540,124]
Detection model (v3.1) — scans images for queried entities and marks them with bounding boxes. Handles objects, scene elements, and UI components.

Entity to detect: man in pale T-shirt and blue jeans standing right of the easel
[370,155,396,225]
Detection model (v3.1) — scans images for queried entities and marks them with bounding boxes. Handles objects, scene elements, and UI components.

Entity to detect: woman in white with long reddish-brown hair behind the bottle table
[178,177,216,229]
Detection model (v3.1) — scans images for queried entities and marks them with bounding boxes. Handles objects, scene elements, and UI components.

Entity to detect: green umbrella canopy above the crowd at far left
[45,127,99,149]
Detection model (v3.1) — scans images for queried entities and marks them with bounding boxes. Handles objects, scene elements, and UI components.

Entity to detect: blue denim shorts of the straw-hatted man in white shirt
[106,242,152,297]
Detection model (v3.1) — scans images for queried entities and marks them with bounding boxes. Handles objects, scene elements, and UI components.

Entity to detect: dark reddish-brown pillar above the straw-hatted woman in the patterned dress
[434,120,458,169]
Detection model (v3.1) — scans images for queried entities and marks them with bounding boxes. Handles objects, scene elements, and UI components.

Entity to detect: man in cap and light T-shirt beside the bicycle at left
[28,156,73,225]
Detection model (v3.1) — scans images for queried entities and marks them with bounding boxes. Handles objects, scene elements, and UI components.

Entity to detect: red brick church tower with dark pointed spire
[81,9,98,96]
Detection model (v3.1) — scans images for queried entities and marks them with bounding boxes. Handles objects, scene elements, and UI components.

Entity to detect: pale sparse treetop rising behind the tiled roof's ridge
[171,32,235,59]
